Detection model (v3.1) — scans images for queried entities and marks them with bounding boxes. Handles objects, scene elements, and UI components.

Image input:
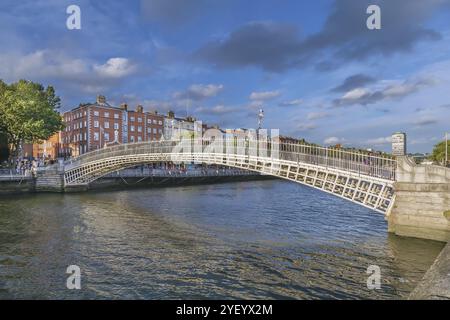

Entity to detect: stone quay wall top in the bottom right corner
[409,243,450,300]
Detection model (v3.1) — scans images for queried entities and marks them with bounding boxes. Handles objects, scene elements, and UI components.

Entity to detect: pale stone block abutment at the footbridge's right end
[387,157,450,242]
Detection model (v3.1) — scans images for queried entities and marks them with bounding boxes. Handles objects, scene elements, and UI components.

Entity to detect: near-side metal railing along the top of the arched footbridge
[65,139,397,180]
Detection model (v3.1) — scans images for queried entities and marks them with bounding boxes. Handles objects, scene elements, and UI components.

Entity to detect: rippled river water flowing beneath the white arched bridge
[0,180,443,299]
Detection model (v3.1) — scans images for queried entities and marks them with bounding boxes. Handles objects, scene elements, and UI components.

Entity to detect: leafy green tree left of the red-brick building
[0,80,63,159]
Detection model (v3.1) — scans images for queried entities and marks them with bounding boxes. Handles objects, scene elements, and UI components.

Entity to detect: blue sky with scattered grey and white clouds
[0,0,450,152]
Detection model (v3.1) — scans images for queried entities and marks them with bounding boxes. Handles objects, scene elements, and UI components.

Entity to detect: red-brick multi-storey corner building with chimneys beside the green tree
[60,96,164,156]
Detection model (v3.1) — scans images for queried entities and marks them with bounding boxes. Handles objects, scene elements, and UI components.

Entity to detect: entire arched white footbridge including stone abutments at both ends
[32,138,450,241]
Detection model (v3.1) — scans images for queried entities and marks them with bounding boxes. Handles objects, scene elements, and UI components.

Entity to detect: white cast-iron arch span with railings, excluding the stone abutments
[64,138,396,214]
